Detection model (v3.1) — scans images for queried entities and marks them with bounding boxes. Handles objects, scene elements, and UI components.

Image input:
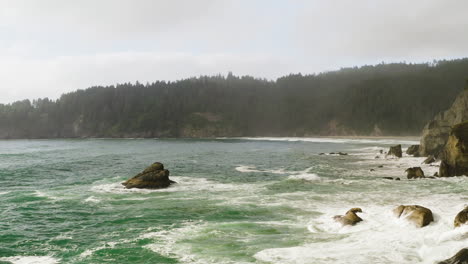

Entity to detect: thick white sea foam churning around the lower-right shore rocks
[254,195,468,264]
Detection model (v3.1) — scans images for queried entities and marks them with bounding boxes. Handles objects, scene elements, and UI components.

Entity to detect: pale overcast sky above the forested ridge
[0,0,468,103]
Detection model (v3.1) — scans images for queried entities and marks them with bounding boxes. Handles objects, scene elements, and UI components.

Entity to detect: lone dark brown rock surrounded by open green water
[122,162,175,189]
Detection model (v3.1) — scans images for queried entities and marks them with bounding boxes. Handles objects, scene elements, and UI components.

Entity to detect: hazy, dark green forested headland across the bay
[0,59,468,138]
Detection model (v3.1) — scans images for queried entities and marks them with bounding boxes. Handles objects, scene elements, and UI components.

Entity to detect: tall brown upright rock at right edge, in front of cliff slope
[439,122,468,177]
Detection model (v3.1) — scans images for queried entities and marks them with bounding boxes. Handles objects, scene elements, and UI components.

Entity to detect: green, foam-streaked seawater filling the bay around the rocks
[0,139,468,264]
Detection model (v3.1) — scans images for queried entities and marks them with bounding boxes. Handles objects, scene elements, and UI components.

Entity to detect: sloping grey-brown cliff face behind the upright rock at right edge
[419,86,468,156]
